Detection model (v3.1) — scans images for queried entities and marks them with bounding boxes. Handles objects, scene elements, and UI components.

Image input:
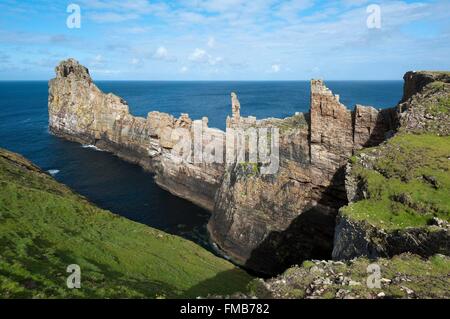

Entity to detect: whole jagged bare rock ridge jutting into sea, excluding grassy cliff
[49,59,398,274]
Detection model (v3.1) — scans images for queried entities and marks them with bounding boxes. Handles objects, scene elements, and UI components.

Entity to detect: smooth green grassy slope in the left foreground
[0,149,252,298]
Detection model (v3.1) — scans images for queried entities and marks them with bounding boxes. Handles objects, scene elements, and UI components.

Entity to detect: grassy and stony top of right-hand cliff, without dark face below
[342,78,450,230]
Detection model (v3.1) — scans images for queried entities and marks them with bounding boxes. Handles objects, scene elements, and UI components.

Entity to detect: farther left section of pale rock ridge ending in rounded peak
[48,59,224,211]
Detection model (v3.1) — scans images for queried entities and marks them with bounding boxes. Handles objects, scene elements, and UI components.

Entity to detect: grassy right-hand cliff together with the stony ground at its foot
[246,72,450,299]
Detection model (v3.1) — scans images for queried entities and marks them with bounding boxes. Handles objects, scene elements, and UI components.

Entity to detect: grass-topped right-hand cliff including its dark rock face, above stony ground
[333,77,450,259]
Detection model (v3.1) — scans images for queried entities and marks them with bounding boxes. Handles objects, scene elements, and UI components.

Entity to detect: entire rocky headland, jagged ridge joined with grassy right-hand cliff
[49,59,449,275]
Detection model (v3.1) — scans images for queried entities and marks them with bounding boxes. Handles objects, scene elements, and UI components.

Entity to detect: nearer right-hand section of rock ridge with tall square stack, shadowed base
[208,80,397,275]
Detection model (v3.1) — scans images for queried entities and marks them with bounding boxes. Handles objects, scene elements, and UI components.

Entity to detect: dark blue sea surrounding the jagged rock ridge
[0,81,403,247]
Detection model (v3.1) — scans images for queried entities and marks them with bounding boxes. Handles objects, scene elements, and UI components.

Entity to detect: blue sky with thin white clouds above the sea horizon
[0,0,450,80]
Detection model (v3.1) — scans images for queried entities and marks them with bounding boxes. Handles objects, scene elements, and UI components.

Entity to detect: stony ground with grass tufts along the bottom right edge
[248,254,450,299]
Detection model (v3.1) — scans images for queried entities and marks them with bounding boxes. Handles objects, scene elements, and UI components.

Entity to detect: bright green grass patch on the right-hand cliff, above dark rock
[342,133,450,229]
